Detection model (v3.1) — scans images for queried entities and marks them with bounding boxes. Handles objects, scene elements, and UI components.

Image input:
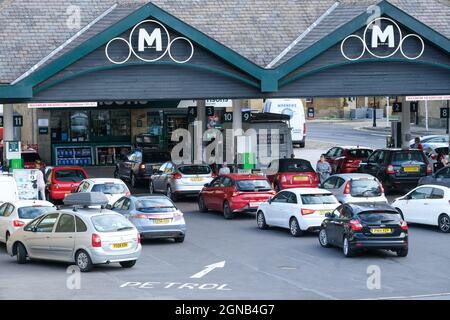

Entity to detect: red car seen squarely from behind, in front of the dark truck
[267,159,320,192]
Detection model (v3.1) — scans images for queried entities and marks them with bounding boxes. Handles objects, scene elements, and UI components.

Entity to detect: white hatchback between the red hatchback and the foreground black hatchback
[256,188,340,237]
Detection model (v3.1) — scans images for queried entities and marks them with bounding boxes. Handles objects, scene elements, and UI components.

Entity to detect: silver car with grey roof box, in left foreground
[6,193,141,272]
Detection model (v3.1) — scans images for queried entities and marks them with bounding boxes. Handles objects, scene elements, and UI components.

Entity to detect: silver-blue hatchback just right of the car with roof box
[112,195,186,242]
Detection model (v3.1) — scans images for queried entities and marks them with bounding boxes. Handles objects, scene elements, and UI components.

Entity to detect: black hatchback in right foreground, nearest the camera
[319,203,408,257]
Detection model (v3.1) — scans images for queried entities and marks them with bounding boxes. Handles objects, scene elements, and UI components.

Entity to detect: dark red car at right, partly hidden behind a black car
[325,146,373,173]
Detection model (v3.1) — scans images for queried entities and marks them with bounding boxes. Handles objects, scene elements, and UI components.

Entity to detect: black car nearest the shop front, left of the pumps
[114,149,170,188]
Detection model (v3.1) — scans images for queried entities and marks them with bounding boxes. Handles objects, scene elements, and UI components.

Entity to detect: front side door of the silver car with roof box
[23,213,59,259]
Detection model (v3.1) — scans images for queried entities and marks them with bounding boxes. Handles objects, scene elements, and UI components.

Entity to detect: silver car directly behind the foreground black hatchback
[320,173,388,203]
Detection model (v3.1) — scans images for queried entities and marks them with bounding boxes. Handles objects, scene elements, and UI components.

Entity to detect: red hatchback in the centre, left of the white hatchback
[198,174,275,219]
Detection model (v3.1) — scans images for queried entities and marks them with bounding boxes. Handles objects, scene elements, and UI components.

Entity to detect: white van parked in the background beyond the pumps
[264,99,306,148]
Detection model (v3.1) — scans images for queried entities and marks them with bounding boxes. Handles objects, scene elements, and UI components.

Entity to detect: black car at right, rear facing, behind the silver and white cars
[358,149,433,190]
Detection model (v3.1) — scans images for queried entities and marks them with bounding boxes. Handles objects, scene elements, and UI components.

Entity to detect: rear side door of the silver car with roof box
[50,213,75,261]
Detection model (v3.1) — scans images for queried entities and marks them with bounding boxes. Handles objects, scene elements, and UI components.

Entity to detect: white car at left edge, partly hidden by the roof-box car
[0,200,55,243]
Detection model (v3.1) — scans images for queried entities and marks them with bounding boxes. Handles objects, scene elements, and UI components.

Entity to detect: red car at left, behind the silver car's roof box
[45,166,88,202]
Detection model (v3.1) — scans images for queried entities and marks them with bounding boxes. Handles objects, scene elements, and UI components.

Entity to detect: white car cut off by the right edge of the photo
[392,185,450,233]
